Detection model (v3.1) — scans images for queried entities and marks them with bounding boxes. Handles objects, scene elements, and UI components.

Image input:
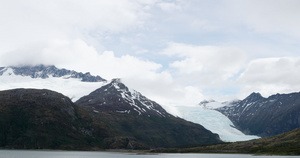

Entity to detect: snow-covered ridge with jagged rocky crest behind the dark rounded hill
[0,65,107,101]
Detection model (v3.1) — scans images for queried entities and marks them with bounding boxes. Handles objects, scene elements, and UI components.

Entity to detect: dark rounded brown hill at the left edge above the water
[0,89,110,150]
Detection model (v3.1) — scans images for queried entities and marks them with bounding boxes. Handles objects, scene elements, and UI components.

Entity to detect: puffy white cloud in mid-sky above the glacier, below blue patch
[162,43,246,84]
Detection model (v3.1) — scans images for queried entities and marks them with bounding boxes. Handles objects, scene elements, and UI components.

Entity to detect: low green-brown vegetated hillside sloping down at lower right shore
[153,128,300,155]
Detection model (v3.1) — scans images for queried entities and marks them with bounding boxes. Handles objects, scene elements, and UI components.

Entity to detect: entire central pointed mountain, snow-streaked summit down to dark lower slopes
[76,79,221,148]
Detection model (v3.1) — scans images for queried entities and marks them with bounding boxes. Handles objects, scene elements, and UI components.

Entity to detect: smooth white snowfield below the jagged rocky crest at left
[0,68,109,102]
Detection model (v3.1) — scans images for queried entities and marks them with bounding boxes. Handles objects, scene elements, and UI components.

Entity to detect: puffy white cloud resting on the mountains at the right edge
[237,57,300,97]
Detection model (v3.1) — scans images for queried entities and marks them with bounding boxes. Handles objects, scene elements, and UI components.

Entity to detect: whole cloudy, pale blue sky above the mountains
[0,0,300,105]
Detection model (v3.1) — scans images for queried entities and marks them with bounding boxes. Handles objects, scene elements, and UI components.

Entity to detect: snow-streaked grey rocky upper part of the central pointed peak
[76,79,170,117]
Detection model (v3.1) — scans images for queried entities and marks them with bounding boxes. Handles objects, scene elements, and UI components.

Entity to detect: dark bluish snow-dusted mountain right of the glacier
[216,93,300,137]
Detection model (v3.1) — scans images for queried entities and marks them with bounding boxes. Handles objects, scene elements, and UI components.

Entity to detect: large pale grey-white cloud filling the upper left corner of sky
[0,0,154,52]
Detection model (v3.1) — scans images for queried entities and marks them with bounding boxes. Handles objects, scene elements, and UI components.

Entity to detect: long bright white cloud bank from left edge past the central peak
[0,39,161,79]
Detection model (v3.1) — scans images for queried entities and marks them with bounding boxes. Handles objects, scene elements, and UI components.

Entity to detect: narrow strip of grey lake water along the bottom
[0,150,295,158]
